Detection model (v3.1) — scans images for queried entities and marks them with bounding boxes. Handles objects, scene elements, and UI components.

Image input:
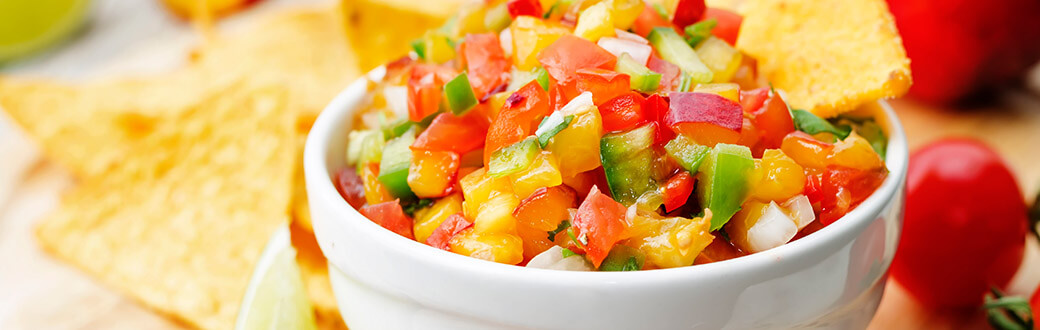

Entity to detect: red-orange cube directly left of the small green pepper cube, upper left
[408,64,456,122]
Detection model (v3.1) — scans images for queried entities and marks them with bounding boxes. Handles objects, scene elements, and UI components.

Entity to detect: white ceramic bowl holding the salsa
[304,69,908,330]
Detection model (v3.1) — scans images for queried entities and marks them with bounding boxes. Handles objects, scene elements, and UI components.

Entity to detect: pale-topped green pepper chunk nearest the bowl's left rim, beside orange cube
[379,129,415,199]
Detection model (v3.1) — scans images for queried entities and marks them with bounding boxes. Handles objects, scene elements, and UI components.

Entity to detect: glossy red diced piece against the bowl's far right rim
[820,166,885,226]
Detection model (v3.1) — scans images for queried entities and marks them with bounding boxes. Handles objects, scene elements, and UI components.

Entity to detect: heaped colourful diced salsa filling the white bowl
[334,0,887,271]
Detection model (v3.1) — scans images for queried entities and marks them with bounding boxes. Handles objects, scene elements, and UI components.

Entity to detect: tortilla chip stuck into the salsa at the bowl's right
[736,0,910,118]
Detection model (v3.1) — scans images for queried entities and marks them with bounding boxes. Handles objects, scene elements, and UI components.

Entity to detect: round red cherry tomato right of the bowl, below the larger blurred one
[891,139,1026,308]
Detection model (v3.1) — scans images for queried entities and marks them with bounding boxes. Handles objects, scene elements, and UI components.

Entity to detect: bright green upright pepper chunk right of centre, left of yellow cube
[697,144,755,231]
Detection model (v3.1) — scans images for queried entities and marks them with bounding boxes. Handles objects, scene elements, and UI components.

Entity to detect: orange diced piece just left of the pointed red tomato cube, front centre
[513,185,577,231]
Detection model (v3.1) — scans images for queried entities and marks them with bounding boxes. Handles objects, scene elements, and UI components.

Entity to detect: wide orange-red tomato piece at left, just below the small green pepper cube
[412,111,488,155]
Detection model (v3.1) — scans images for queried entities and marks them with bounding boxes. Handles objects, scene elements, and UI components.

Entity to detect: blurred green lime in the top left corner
[0,0,89,62]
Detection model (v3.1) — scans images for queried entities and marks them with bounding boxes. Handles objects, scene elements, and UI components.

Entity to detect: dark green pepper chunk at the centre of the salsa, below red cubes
[599,125,654,205]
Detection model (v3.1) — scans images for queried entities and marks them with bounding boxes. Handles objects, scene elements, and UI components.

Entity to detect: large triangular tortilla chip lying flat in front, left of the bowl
[37,84,295,329]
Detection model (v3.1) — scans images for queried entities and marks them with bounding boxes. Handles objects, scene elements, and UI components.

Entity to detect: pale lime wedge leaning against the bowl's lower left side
[235,227,317,330]
